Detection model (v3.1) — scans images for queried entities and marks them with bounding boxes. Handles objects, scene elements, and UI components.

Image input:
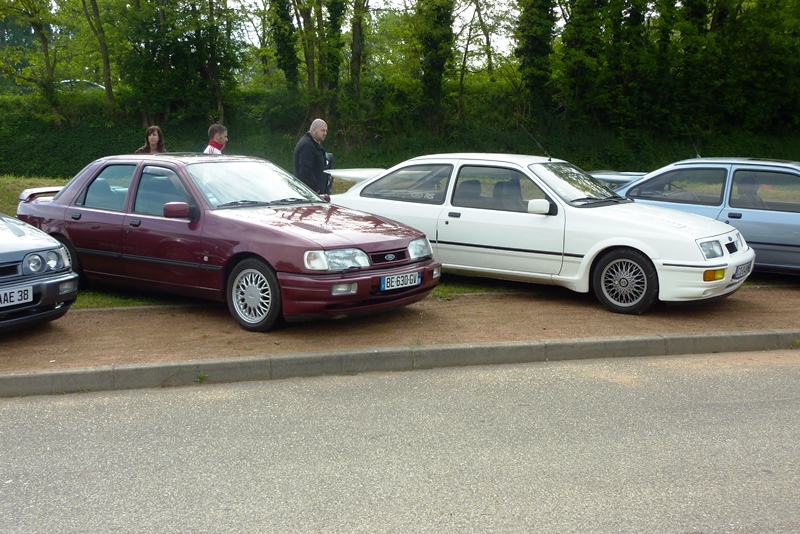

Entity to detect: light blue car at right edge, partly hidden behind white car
[615,158,800,274]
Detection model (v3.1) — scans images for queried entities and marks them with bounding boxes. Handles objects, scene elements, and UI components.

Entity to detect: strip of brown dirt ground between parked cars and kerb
[0,283,800,373]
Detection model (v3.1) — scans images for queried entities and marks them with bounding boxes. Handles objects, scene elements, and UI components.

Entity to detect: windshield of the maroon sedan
[186,160,320,208]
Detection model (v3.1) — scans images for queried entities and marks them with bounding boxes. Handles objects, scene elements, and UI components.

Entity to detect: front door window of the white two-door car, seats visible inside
[453,166,545,212]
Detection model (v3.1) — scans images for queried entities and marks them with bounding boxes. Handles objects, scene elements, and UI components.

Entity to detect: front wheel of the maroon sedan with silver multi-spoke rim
[226,258,281,332]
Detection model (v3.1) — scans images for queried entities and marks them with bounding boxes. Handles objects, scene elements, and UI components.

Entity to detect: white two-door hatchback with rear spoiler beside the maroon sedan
[328,153,755,314]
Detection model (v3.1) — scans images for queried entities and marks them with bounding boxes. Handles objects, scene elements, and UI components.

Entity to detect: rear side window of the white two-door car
[361,164,453,204]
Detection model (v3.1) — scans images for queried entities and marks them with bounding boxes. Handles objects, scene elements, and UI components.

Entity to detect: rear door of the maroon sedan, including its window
[64,164,136,278]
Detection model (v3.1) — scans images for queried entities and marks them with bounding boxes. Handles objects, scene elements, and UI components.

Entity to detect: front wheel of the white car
[592,249,658,315]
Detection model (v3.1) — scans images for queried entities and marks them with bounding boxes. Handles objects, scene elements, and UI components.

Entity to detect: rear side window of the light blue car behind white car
[628,169,727,206]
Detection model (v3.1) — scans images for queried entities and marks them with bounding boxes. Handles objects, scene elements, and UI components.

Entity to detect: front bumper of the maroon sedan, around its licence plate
[278,260,441,321]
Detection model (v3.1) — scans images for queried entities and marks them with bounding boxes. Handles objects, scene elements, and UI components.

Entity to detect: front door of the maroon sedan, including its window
[123,165,213,296]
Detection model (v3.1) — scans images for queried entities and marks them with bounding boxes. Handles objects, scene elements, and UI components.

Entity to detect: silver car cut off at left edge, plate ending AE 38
[0,213,78,333]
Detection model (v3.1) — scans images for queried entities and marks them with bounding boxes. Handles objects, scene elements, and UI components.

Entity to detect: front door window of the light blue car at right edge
[731,170,800,213]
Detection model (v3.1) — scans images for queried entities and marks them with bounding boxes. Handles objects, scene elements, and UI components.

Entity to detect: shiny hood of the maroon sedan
[213,204,424,246]
